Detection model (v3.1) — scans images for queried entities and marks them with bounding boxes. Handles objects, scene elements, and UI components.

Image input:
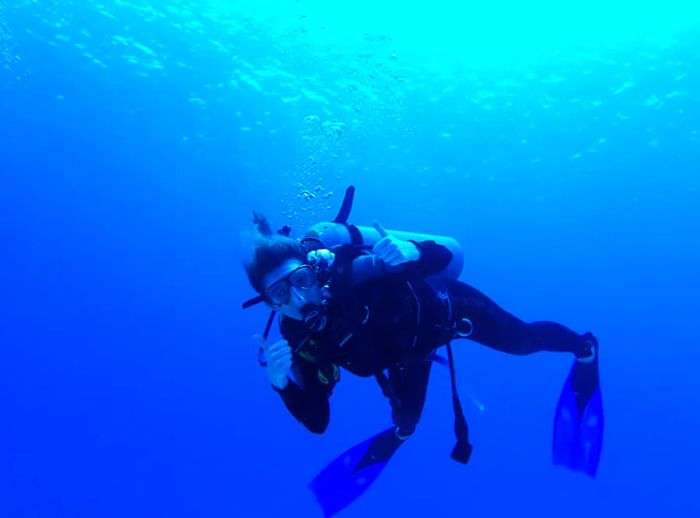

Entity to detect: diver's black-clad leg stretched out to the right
[450,282,597,358]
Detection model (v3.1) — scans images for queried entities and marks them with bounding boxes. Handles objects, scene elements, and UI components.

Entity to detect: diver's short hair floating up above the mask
[243,212,306,295]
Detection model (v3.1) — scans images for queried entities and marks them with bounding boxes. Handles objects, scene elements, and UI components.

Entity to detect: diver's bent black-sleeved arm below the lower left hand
[272,358,336,434]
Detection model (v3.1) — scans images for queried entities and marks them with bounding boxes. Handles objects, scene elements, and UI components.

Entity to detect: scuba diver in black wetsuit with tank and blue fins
[244,187,603,516]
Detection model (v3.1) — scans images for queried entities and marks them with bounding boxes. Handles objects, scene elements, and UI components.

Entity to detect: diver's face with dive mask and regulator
[263,259,321,320]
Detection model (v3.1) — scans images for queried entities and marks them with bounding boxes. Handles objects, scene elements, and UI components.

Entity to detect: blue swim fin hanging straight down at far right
[552,357,605,477]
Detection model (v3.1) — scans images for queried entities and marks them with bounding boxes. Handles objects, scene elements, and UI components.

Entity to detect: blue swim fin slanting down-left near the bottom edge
[309,427,405,518]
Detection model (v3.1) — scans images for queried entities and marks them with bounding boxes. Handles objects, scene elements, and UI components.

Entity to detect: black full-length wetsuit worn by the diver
[275,241,590,435]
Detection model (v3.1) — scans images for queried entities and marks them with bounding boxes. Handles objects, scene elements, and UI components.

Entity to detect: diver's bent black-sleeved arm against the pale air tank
[352,241,452,285]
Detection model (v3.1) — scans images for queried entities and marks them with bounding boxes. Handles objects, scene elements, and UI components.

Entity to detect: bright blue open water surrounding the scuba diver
[0,0,700,518]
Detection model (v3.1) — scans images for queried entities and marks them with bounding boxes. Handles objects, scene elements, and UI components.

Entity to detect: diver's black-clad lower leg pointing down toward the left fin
[389,361,432,437]
